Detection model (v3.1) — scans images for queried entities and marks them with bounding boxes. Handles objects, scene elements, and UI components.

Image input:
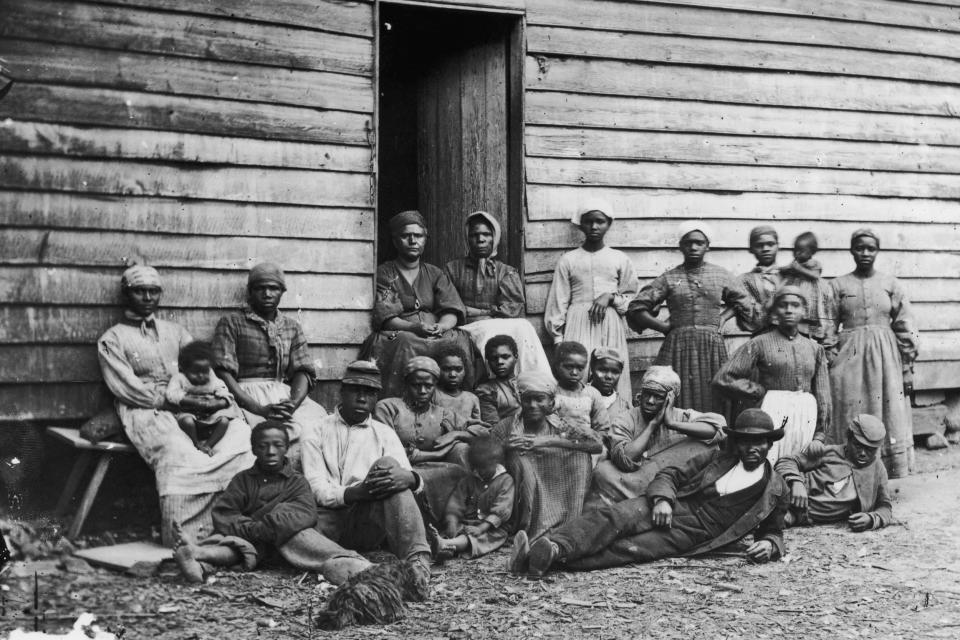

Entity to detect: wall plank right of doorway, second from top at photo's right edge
[527,0,960,58]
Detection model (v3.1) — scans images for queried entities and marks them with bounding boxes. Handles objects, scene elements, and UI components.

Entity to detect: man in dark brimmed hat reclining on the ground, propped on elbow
[510,409,789,577]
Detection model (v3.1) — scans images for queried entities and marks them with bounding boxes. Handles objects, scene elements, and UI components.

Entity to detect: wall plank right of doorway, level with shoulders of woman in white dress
[525,249,960,278]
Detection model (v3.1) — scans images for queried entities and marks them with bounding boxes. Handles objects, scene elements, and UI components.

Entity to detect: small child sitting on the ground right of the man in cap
[430,436,515,561]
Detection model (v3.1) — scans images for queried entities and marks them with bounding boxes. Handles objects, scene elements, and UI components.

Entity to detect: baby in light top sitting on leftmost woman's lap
[166,340,240,456]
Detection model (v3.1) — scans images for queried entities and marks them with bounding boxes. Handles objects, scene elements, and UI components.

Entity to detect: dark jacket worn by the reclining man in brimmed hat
[647,451,790,558]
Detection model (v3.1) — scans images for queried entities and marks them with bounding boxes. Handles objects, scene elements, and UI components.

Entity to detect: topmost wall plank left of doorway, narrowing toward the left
[97,0,373,38]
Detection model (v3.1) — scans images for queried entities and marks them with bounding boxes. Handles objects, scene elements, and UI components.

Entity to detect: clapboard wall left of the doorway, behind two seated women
[0,0,375,420]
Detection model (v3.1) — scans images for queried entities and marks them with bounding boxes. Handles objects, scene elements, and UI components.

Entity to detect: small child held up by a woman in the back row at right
[780,231,834,346]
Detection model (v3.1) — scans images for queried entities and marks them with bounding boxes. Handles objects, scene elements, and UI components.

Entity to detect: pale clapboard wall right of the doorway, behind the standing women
[525,0,960,389]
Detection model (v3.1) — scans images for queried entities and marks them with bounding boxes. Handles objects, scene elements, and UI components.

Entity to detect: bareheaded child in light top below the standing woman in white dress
[553,342,610,434]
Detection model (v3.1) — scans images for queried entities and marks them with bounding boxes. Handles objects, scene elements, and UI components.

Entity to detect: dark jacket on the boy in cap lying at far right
[776,445,893,529]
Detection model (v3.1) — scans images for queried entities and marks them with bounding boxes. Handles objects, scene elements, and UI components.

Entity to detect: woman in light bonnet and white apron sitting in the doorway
[444,211,550,380]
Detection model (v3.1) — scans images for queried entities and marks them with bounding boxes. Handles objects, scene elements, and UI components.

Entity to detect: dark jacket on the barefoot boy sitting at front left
[213,462,317,546]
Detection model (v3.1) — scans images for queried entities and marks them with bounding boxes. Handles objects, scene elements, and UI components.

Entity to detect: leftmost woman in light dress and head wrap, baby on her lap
[97,265,253,546]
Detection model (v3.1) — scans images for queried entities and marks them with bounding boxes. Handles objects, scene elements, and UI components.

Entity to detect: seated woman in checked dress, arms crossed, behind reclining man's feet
[493,371,603,538]
